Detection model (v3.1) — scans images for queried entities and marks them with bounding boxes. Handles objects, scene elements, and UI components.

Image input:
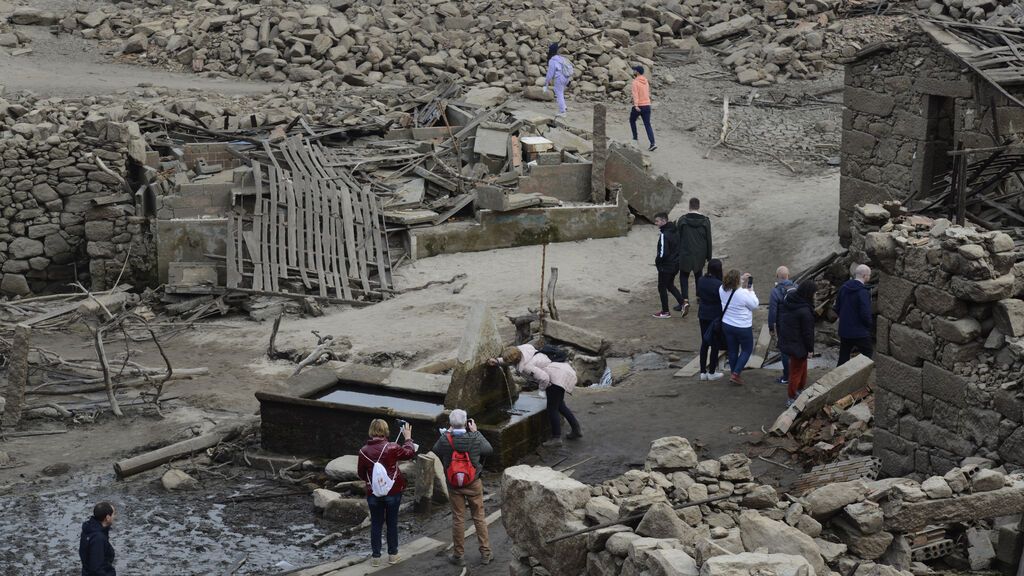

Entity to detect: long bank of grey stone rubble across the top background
[6,0,872,88]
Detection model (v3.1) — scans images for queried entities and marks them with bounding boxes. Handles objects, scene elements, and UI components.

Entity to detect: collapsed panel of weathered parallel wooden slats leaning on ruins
[227,136,393,299]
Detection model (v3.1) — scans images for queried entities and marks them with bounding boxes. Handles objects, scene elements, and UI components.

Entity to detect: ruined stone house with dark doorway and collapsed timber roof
[839,23,1024,245]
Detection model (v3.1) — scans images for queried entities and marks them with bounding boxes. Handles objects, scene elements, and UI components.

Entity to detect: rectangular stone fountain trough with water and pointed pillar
[256,305,549,468]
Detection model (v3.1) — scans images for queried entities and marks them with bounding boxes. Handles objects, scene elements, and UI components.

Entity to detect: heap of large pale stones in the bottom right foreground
[502,437,1024,576]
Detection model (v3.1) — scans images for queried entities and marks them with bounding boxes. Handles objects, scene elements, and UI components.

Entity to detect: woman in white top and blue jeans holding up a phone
[718,270,760,384]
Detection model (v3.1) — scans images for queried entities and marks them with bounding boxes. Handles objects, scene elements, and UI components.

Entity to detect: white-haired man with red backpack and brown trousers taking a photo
[433,410,494,566]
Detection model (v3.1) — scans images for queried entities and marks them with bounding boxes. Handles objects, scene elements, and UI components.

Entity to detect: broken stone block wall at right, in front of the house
[851,205,1024,476]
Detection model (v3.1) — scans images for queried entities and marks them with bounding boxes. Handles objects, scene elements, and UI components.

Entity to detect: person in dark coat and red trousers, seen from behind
[778,280,818,406]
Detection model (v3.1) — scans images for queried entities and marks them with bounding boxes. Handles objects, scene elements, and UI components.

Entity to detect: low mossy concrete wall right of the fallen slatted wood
[409,189,631,258]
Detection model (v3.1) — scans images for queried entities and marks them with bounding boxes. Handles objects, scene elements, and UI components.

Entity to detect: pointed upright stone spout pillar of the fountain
[444,302,512,414]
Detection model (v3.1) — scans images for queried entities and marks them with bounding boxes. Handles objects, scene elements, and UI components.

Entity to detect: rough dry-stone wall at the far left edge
[0,113,155,296]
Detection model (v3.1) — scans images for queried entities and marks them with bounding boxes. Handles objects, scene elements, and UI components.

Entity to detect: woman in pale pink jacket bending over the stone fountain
[487,344,583,446]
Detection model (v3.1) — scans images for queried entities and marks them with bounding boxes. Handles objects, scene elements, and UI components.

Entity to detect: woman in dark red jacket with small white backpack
[356,418,416,568]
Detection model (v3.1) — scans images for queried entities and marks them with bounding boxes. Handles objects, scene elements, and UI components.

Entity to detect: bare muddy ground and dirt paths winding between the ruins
[0,2,842,576]
